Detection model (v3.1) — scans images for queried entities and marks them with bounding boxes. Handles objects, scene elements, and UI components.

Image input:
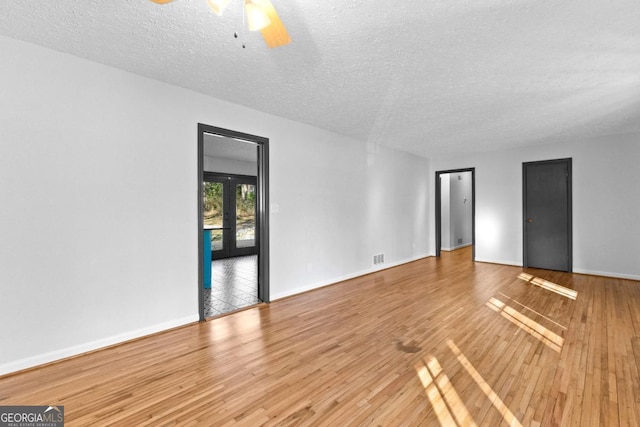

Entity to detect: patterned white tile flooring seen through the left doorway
[204,255,260,317]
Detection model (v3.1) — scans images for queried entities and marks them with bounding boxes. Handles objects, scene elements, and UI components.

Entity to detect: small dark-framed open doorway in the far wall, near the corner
[435,168,476,261]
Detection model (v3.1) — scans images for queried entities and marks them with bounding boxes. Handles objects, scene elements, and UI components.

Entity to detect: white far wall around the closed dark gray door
[431,135,640,279]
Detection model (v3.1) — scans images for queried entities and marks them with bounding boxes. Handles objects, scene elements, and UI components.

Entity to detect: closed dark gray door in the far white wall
[522,159,572,271]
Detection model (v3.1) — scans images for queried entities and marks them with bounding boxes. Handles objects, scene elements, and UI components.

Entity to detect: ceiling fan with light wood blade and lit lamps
[151,0,291,48]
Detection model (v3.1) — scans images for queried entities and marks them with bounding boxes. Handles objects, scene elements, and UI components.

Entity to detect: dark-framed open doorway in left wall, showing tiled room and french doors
[198,124,269,321]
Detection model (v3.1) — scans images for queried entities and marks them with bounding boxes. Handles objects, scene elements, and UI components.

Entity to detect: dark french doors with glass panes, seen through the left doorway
[202,172,258,259]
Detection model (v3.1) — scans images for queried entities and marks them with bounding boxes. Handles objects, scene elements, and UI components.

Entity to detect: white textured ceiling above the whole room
[0,0,640,157]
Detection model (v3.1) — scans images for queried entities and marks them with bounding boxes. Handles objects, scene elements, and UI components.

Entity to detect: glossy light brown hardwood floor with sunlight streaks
[0,250,640,426]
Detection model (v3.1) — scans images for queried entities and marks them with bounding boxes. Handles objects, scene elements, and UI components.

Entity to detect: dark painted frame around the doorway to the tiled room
[197,123,270,322]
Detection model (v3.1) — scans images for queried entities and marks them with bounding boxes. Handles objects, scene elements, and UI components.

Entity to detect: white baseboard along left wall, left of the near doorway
[0,315,199,375]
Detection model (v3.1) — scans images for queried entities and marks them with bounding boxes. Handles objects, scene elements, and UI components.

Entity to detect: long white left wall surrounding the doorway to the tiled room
[0,37,430,374]
